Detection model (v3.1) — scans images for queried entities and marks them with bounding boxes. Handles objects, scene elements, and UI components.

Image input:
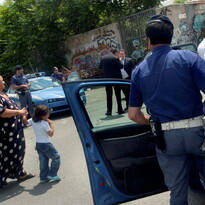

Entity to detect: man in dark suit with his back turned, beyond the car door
[100,49,124,115]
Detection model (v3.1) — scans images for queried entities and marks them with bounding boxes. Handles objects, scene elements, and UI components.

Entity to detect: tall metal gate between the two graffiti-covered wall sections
[118,8,156,60]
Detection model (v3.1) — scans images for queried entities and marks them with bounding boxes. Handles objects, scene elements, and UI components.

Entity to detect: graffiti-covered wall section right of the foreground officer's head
[158,3,205,45]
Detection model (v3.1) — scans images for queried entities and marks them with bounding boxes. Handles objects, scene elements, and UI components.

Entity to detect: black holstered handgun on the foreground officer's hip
[150,119,166,152]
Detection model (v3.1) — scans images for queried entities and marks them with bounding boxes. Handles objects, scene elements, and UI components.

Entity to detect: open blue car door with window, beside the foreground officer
[63,79,167,205]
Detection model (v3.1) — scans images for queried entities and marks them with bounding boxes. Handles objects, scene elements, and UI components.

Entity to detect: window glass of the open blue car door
[81,85,146,128]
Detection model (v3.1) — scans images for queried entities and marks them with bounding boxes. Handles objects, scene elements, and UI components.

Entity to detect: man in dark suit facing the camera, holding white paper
[119,49,135,111]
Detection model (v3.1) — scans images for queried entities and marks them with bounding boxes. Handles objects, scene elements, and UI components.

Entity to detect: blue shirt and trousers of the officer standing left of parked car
[11,71,33,115]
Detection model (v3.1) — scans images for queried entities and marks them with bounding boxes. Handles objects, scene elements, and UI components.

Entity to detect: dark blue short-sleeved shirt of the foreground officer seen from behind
[129,46,205,122]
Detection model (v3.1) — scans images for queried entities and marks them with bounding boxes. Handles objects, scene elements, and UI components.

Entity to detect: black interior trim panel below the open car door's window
[94,124,167,194]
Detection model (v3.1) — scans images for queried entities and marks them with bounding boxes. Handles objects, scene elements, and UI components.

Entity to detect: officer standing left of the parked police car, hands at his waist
[11,65,33,116]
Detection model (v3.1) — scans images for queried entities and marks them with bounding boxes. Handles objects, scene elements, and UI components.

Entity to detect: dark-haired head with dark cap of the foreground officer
[145,15,174,45]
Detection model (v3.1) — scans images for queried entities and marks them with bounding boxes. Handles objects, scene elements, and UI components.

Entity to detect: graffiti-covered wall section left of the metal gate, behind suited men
[65,24,121,79]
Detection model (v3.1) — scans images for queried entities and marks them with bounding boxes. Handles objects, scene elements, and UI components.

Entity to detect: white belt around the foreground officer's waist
[161,115,204,130]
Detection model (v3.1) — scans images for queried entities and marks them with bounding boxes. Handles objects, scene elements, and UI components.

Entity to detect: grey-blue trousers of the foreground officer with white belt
[156,127,205,205]
